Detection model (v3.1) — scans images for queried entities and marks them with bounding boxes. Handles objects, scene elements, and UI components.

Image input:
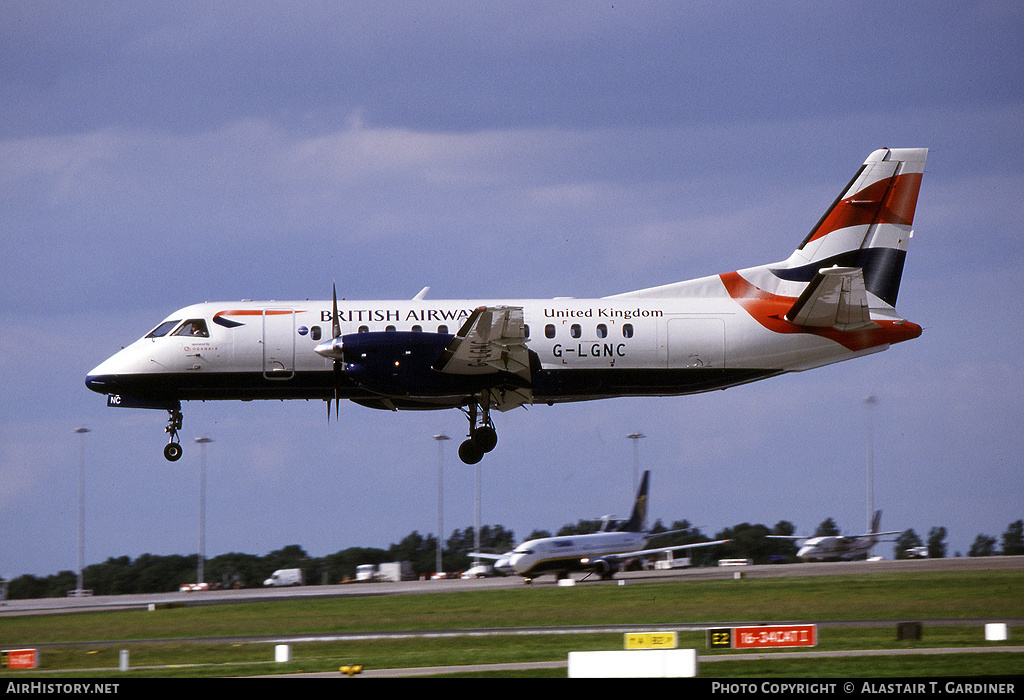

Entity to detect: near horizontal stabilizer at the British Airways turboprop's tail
[785,267,873,331]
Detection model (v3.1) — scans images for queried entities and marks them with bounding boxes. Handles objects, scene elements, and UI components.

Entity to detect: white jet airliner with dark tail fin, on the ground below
[470,472,729,583]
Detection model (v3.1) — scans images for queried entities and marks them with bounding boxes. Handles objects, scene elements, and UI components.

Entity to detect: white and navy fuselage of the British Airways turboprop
[86,290,920,408]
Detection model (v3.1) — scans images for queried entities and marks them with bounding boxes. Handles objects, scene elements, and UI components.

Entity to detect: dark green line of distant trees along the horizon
[7,518,1024,600]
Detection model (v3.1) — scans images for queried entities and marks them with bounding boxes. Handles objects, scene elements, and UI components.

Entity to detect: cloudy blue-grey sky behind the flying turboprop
[0,0,1024,578]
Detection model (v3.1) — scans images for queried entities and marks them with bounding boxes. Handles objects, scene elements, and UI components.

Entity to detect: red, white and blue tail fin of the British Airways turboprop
[770,148,928,306]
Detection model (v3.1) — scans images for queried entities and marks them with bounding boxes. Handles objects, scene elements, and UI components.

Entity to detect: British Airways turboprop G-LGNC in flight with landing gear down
[85,148,928,464]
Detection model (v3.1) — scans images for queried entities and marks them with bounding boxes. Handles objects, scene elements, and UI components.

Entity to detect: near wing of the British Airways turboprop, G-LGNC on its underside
[433,306,534,410]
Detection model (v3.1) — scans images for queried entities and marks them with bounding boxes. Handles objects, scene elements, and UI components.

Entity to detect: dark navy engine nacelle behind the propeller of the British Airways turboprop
[340,331,496,396]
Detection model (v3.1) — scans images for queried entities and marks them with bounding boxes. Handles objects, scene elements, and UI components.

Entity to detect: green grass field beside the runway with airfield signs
[0,571,1024,677]
